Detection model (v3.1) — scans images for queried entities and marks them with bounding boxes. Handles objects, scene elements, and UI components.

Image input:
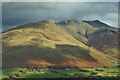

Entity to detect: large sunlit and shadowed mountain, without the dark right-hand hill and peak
[2,20,116,68]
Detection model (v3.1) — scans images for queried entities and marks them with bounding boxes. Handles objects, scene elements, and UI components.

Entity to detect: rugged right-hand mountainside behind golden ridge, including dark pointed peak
[57,19,119,58]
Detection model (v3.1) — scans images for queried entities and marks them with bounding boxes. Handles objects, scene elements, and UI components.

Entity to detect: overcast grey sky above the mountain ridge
[2,2,118,28]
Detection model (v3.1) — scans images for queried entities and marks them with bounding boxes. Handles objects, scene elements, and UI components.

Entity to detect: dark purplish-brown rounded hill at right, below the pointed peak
[88,29,119,58]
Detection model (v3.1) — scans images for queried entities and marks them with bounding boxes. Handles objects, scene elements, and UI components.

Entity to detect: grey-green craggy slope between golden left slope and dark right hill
[56,20,98,44]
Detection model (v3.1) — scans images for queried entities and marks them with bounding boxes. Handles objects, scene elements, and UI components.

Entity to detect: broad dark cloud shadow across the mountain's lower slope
[3,44,96,67]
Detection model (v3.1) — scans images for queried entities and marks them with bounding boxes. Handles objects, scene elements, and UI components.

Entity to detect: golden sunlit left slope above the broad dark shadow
[3,21,85,47]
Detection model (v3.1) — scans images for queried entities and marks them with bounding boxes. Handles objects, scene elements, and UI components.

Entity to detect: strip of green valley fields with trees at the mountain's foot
[2,67,119,78]
